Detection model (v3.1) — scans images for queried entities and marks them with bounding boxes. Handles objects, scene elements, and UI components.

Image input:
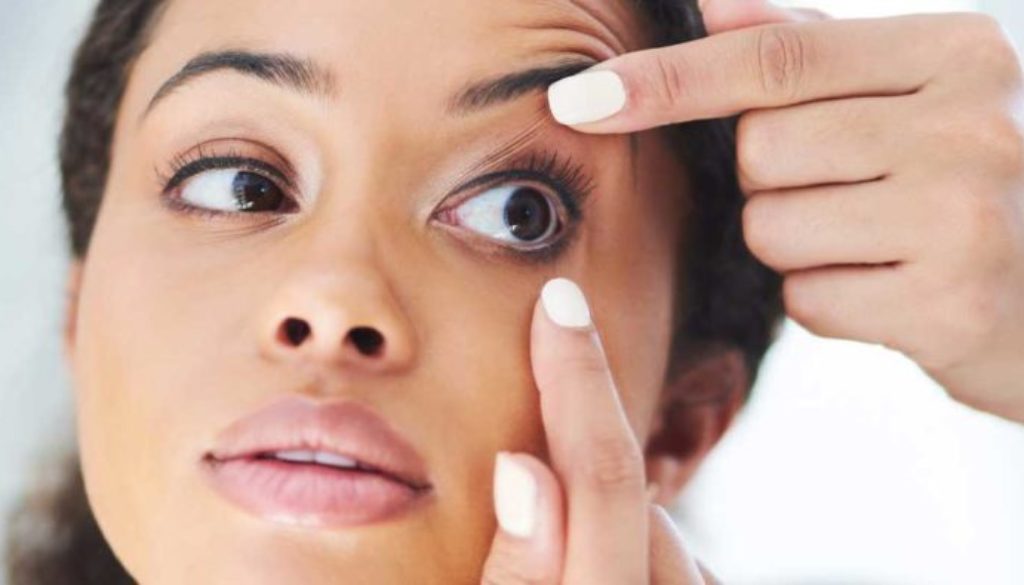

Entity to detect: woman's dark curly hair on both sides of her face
[6,0,782,585]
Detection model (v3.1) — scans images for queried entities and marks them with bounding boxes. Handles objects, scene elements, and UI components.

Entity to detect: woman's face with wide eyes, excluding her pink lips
[64,0,683,584]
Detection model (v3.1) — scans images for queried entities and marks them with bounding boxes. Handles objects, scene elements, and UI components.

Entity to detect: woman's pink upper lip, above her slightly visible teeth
[205,396,430,490]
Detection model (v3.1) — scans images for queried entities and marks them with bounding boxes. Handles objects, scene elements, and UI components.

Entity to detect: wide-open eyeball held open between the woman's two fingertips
[452,184,562,248]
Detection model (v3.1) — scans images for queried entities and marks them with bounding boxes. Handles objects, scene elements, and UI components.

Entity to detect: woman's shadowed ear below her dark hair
[645,347,750,505]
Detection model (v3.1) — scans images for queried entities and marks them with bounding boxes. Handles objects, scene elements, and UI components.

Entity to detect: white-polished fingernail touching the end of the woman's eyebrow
[548,70,626,124]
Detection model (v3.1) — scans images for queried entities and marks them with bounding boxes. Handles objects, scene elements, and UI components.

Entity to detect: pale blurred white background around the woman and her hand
[0,0,1024,585]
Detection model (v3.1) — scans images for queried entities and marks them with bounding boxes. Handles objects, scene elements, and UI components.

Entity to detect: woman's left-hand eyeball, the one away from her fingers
[178,169,291,213]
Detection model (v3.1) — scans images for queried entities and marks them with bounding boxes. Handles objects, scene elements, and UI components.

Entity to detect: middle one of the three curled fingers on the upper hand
[742,179,927,273]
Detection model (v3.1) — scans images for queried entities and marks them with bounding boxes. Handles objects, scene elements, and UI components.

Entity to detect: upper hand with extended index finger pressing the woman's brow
[549,0,1024,421]
